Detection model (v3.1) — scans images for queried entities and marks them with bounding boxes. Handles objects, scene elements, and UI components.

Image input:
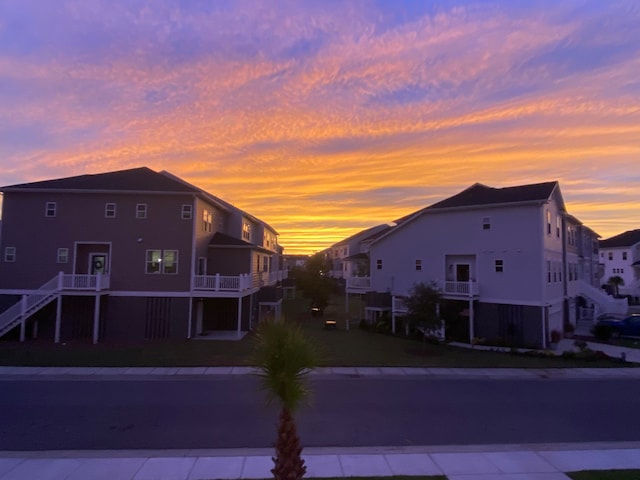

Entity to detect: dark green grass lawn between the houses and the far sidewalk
[0,296,636,368]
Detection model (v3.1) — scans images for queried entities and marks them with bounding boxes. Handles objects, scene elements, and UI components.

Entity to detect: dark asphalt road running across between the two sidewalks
[0,376,640,450]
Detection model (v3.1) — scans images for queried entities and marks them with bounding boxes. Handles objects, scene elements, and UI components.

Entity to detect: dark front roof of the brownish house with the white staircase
[0,167,200,193]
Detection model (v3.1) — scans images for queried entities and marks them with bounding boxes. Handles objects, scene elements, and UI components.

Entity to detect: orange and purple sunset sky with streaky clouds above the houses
[0,0,640,253]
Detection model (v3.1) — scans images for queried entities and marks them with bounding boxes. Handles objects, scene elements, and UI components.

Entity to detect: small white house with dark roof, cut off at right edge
[600,229,640,297]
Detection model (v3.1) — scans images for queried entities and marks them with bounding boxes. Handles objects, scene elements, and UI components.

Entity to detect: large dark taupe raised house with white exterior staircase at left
[0,167,285,343]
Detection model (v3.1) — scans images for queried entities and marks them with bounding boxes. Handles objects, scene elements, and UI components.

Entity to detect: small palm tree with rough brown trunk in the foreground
[254,321,317,480]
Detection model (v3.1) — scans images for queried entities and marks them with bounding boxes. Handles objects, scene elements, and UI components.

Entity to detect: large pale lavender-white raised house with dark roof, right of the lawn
[347,182,626,347]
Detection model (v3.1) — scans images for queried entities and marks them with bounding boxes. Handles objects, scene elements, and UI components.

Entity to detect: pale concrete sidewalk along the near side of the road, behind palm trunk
[0,443,640,480]
